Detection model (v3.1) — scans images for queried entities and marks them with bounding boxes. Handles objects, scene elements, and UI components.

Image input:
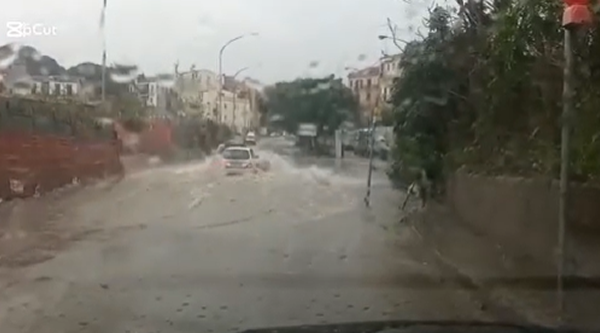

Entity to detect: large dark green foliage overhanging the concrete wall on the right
[390,0,600,187]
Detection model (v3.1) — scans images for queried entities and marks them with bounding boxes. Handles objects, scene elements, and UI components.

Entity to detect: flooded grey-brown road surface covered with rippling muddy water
[0,137,496,333]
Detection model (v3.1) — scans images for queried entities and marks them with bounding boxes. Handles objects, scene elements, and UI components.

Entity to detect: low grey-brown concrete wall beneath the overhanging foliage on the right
[447,171,600,275]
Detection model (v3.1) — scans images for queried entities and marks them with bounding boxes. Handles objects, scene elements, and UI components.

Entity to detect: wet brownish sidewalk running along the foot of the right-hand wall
[409,204,600,329]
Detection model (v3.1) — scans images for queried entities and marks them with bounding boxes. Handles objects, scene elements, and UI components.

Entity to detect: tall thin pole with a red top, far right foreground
[556,0,592,319]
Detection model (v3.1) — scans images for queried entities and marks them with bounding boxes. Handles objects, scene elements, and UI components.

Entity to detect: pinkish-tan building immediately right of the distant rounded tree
[348,66,381,124]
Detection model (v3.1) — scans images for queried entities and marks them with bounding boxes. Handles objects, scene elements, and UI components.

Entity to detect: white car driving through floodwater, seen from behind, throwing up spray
[221,147,271,175]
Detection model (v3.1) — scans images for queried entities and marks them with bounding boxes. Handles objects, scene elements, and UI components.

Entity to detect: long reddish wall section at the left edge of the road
[0,132,123,199]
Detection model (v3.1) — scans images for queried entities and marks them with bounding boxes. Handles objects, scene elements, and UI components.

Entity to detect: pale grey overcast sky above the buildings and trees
[0,0,427,83]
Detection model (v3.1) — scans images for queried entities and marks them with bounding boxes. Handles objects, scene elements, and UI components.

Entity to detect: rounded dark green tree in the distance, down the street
[266,76,358,135]
